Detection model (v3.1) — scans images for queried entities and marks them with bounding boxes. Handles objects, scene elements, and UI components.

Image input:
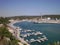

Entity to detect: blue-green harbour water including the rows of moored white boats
[13,21,60,45]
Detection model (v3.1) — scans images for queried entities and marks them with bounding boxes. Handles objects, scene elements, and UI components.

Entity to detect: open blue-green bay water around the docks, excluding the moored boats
[14,21,60,45]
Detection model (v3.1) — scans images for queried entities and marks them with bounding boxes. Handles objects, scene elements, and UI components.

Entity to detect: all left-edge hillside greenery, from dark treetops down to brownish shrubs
[0,17,18,45]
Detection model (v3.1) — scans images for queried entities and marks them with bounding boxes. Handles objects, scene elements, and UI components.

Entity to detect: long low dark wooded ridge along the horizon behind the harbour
[7,15,60,19]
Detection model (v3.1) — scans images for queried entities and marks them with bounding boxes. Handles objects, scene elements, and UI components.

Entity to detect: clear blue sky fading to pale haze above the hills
[0,0,60,16]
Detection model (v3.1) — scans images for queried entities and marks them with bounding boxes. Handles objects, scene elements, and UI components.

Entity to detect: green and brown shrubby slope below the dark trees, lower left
[0,26,18,45]
